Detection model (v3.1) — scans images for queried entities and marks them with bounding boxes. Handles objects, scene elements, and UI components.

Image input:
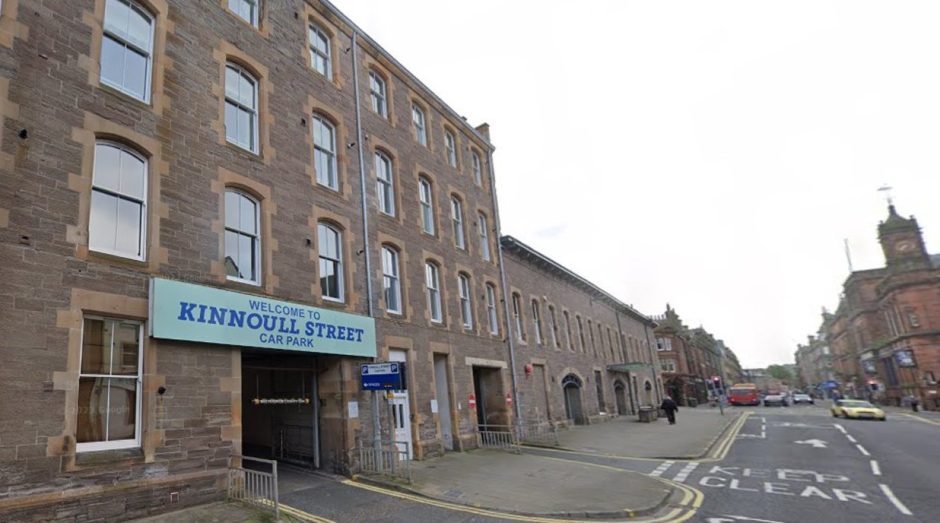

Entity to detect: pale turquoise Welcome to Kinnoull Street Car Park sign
[150,278,376,358]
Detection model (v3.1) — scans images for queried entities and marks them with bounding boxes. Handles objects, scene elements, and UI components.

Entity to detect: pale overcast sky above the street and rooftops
[334,0,940,368]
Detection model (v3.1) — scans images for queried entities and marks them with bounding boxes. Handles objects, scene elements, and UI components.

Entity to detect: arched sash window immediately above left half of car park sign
[225,189,261,284]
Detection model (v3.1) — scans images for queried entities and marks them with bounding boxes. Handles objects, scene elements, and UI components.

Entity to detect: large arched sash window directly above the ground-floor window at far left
[88,142,147,260]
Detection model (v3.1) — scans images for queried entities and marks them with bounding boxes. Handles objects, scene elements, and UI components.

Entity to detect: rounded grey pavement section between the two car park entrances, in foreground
[359,449,675,518]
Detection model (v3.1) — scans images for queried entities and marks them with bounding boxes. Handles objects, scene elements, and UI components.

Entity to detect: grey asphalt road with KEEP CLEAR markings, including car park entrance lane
[272,406,940,523]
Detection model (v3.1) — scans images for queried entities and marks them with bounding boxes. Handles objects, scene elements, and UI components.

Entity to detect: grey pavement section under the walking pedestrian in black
[558,407,744,459]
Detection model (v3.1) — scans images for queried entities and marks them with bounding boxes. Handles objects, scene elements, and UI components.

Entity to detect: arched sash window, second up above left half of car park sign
[225,63,258,153]
